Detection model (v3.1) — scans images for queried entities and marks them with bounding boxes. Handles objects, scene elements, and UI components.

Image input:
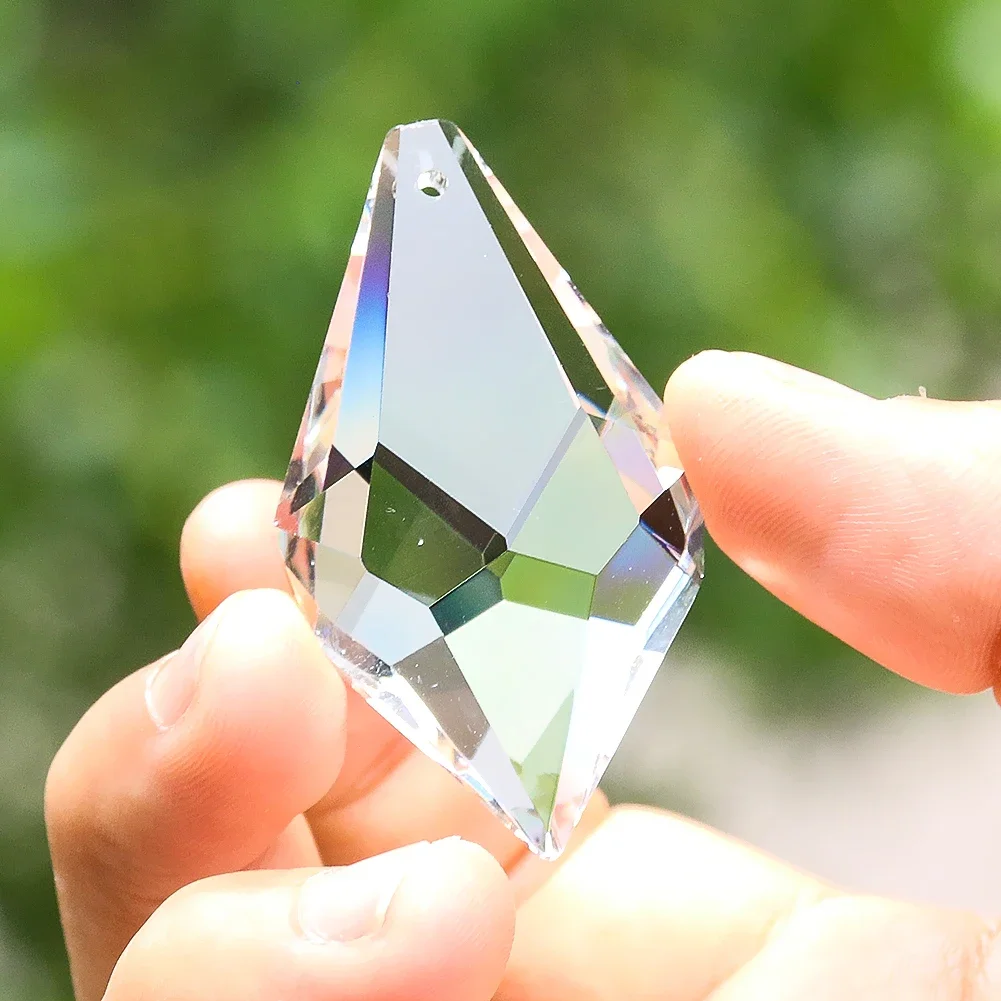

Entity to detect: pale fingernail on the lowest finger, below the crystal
[297,841,430,942]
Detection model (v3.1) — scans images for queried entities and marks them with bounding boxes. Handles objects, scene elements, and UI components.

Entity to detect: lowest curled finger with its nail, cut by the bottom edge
[105,839,515,1001]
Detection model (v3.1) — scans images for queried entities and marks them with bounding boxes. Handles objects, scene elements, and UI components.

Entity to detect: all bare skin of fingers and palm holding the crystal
[46,351,1001,1001]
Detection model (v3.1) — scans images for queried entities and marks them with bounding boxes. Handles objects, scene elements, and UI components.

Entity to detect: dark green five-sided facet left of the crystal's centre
[361,457,483,605]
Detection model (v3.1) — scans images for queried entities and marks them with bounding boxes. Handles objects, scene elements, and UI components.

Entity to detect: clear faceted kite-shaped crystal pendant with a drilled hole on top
[276,121,702,858]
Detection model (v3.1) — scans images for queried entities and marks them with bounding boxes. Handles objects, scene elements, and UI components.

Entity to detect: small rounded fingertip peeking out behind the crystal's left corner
[180,479,288,619]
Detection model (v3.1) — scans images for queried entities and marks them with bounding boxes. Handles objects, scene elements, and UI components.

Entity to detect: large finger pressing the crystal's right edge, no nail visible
[665,351,1001,692]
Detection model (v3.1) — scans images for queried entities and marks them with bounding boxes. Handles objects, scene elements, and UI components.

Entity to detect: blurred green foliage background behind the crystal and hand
[0,0,1001,1001]
